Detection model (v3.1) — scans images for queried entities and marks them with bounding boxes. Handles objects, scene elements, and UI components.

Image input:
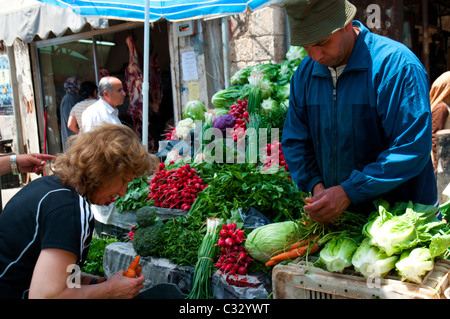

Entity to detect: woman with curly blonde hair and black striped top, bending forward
[0,124,159,298]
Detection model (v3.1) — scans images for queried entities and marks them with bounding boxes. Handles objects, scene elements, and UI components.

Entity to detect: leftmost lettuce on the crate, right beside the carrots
[319,233,358,272]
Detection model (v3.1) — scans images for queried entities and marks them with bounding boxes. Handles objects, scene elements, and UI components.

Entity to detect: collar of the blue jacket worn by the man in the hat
[312,20,372,77]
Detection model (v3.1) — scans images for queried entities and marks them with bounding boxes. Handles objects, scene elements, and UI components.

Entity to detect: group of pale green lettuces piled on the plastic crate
[319,200,450,283]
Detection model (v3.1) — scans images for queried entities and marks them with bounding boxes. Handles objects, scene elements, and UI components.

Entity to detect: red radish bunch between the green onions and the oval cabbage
[216,223,252,275]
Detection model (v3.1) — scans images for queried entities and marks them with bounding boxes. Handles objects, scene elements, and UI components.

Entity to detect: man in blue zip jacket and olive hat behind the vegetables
[282,0,439,223]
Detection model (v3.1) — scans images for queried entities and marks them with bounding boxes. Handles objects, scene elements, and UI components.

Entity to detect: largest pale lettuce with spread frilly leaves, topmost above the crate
[363,202,443,256]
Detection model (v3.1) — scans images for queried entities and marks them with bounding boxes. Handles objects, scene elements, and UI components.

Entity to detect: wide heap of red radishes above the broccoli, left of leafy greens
[147,163,208,210]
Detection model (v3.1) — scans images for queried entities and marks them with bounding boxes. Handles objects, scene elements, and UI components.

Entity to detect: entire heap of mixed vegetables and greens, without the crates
[110,42,450,299]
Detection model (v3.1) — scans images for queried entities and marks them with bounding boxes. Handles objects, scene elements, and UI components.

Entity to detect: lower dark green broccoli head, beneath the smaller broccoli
[133,220,164,257]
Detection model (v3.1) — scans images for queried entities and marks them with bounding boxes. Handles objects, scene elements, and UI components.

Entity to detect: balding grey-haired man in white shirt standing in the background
[81,76,126,132]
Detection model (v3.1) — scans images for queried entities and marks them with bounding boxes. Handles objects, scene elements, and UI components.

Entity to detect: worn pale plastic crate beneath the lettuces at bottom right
[272,259,450,299]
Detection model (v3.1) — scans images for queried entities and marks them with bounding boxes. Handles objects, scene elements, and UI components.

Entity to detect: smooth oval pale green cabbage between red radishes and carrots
[245,221,298,263]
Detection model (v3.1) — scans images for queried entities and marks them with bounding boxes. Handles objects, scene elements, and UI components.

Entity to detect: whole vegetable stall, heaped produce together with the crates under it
[98,47,450,299]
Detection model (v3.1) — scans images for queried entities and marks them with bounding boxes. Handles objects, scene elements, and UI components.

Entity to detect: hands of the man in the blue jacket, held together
[304,183,351,224]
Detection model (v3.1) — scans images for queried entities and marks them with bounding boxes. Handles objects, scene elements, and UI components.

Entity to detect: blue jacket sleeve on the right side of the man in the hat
[341,65,431,203]
